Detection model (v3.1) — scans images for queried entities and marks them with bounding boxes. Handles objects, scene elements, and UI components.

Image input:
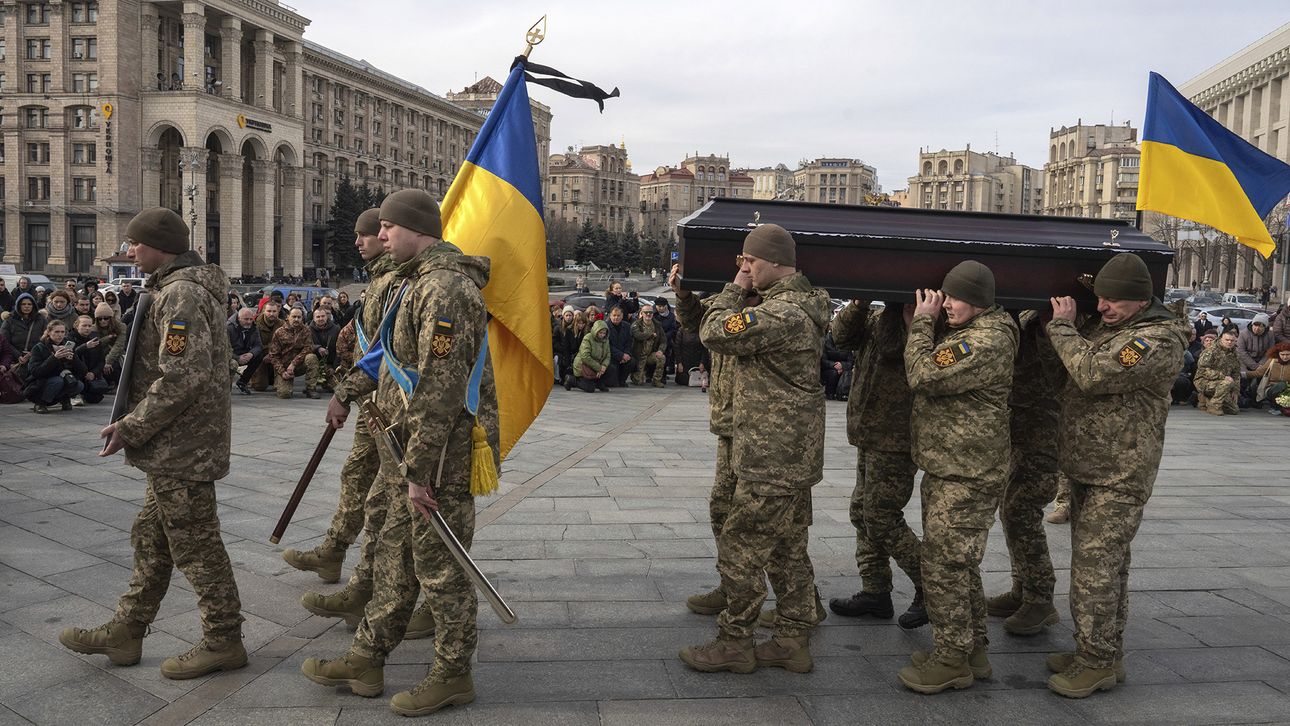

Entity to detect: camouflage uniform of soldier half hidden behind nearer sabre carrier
[323,254,397,562]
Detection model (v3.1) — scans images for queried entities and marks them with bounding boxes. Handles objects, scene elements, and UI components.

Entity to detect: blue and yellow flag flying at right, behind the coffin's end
[1138,74,1290,258]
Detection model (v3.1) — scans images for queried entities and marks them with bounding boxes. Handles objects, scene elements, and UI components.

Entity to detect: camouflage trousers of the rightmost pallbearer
[1071,481,1151,668]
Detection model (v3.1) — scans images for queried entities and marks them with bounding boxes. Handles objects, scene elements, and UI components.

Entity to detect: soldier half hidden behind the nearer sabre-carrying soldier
[290,208,435,640]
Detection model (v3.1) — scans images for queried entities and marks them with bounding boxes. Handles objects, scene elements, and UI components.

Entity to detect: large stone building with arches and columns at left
[0,0,539,277]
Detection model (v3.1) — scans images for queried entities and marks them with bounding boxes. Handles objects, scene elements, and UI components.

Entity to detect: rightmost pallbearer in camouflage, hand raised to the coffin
[1047,253,1188,698]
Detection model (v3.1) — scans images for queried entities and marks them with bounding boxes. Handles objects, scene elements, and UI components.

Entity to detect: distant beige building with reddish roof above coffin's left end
[637,153,753,241]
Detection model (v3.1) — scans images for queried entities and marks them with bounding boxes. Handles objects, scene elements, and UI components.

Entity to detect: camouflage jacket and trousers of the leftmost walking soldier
[114,251,243,646]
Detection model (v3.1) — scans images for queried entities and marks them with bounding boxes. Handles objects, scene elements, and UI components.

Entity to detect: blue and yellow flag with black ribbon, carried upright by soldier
[442,61,555,458]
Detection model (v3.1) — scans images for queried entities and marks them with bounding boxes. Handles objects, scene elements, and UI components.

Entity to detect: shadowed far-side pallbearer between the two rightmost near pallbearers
[986,311,1067,636]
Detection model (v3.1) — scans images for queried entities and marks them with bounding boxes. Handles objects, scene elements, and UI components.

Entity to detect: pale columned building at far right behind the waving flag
[1181,23,1290,297]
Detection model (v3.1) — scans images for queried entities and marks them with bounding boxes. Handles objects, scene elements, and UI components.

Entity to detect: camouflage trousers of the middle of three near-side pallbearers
[922,475,1006,662]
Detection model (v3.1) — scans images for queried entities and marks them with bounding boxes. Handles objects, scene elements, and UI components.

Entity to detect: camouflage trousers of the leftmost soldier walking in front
[112,475,243,643]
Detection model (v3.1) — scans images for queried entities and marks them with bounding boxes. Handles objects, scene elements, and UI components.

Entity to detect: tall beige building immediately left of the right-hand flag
[1044,120,1142,219]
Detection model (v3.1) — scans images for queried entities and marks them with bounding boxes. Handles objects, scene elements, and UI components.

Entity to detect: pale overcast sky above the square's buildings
[298,0,1290,191]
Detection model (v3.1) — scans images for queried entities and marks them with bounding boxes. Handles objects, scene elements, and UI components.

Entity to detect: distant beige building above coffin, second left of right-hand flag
[900,144,1044,214]
